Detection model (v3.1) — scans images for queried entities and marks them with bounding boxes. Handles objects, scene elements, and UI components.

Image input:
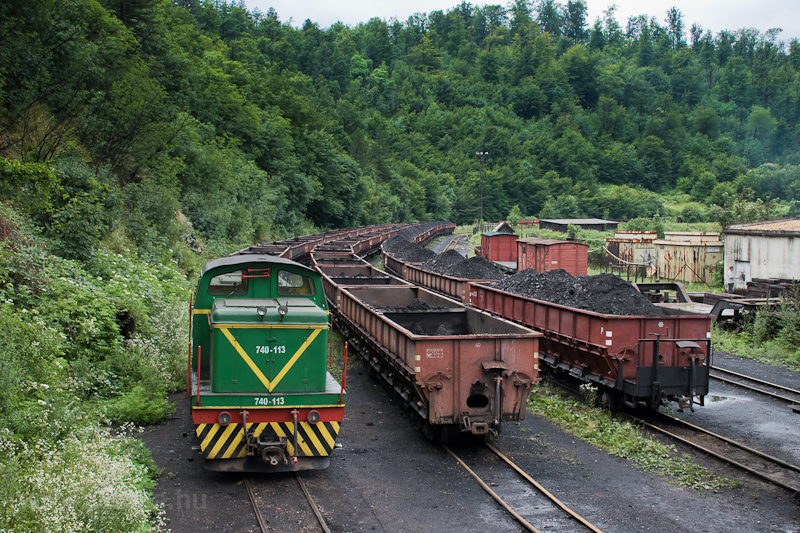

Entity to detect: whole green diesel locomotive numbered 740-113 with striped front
[192,254,346,472]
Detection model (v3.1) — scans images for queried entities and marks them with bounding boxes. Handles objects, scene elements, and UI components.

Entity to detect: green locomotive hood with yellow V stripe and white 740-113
[209,297,329,393]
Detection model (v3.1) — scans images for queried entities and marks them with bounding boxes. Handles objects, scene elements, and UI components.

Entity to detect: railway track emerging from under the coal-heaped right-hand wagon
[628,412,800,495]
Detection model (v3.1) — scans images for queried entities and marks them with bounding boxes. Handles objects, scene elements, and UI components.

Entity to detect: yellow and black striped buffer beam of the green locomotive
[196,422,339,459]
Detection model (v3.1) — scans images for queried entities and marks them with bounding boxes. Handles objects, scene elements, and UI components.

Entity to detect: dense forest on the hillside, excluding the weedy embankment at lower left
[0,0,800,257]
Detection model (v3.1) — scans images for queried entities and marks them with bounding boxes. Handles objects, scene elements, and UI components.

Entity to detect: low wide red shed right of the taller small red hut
[517,237,589,276]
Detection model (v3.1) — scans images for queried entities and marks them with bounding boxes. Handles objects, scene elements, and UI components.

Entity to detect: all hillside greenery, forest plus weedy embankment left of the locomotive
[0,0,800,533]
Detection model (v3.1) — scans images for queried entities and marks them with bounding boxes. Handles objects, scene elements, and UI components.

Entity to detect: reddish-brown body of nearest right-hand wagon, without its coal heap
[469,284,712,407]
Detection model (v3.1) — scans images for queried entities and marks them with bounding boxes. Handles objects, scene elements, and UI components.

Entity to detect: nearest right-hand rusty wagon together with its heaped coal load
[469,270,712,408]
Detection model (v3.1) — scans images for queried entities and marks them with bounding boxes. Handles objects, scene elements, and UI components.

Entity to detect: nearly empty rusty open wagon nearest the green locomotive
[337,286,541,438]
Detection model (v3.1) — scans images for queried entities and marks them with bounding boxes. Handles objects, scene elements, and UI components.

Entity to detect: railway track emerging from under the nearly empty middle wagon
[444,443,602,533]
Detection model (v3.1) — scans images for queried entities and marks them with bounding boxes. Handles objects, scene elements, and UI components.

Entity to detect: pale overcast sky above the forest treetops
[244,0,800,43]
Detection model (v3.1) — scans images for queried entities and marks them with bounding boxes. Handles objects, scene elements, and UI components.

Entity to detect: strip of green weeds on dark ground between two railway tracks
[528,384,737,492]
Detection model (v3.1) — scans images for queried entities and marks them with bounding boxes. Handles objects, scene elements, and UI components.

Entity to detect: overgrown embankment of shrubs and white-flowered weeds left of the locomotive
[0,204,188,533]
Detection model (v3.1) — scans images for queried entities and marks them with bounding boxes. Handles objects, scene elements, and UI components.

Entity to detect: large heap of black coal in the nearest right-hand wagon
[492,269,666,316]
